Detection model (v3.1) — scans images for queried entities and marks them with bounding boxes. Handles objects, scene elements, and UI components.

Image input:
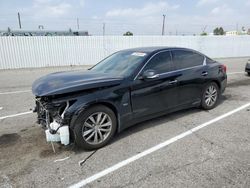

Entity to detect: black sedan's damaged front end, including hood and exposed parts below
[32,71,122,145]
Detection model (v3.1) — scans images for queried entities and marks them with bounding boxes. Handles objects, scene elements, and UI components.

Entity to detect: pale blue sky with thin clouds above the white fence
[0,0,250,35]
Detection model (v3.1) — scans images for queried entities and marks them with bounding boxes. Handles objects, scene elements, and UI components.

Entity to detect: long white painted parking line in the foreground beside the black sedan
[70,103,250,188]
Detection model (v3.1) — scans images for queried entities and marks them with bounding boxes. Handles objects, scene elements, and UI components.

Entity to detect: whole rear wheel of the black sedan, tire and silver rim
[201,82,220,110]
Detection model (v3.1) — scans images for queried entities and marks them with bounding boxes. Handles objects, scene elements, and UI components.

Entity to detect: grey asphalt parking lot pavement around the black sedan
[0,58,250,188]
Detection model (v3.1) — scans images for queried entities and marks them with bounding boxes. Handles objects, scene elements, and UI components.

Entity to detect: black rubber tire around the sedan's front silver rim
[73,105,117,150]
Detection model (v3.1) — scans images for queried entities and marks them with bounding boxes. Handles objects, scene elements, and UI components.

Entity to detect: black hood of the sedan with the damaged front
[32,71,123,97]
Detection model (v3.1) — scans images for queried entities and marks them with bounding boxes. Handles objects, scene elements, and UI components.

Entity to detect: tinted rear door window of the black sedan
[172,50,204,70]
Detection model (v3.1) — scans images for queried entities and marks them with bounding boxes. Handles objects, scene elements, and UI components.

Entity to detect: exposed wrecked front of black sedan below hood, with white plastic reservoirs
[34,97,72,145]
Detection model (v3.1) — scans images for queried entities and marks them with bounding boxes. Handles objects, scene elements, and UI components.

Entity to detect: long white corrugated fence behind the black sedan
[0,36,250,69]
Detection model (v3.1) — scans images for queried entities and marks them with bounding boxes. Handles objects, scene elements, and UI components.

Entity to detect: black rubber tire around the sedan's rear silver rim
[201,82,220,110]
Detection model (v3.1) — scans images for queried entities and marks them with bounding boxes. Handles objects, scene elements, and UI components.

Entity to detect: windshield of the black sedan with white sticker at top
[91,51,147,77]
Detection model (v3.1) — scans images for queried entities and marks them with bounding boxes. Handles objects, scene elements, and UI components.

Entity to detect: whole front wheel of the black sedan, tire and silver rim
[74,105,117,150]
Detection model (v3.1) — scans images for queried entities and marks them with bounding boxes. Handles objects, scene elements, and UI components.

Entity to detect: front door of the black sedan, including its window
[131,51,179,118]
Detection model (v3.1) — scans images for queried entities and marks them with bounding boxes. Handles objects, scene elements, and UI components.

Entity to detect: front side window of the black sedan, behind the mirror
[144,51,171,74]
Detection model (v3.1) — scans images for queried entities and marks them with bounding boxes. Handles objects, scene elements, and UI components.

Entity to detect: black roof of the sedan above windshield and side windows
[122,46,194,53]
